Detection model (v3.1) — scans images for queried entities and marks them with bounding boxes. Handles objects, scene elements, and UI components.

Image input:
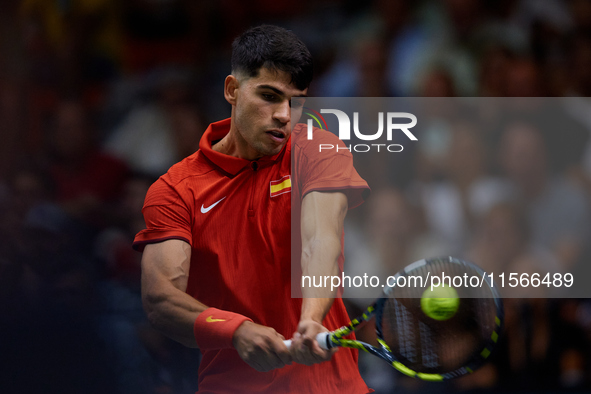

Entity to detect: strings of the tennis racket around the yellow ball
[381,262,504,373]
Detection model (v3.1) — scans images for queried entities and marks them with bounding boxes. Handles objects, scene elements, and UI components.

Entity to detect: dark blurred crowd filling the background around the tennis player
[0,0,591,394]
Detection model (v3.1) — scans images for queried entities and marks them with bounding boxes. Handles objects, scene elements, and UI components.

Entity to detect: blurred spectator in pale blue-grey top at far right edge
[499,121,591,269]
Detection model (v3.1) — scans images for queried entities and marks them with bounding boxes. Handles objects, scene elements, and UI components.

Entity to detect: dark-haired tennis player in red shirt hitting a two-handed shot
[134,25,370,394]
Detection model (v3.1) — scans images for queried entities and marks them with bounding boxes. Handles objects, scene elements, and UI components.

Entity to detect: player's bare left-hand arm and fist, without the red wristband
[142,239,291,371]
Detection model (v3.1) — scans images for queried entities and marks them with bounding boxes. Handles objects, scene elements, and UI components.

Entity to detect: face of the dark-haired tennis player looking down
[233,67,308,160]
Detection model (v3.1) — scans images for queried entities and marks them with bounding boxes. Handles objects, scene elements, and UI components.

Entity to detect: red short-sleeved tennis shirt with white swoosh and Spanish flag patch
[134,119,370,394]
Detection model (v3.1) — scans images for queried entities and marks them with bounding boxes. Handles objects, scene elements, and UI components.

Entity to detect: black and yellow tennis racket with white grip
[285,257,503,382]
